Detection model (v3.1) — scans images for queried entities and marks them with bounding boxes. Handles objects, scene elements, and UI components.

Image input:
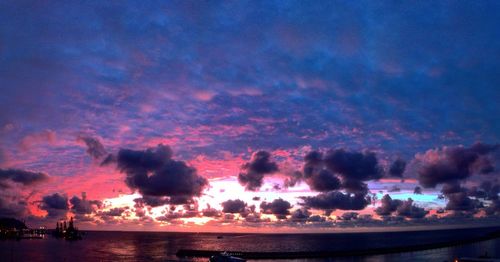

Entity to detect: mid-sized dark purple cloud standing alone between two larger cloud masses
[238,151,278,191]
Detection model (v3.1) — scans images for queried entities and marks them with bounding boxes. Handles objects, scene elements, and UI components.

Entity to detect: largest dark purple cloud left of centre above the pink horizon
[111,144,208,204]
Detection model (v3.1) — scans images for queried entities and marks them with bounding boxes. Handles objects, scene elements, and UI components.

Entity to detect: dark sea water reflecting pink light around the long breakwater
[0,228,500,262]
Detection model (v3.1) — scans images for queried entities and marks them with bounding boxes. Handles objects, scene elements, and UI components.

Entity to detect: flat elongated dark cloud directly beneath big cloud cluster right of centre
[301,191,370,211]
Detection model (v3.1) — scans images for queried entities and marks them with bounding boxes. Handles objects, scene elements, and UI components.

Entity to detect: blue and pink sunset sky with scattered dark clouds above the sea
[0,0,500,232]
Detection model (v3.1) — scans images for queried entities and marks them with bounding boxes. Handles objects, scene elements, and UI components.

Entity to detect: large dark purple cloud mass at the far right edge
[417,143,499,188]
